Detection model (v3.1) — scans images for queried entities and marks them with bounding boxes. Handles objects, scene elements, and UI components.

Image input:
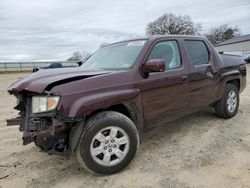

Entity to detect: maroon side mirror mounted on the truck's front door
[143,59,165,73]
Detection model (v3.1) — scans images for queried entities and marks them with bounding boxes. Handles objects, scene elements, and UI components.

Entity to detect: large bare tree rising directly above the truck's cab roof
[146,13,201,36]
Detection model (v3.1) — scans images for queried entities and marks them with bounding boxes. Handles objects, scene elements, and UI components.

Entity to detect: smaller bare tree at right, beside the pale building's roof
[205,24,240,45]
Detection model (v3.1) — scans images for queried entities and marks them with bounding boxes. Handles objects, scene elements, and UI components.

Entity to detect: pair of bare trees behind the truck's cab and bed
[146,13,240,45]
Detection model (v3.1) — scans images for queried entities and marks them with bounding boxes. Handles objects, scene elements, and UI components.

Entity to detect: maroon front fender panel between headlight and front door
[49,71,141,118]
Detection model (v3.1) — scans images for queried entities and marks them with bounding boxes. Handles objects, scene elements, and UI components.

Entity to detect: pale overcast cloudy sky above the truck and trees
[0,0,250,61]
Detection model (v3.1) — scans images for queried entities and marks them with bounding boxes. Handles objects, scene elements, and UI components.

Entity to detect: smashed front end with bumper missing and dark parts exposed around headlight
[7,91,80,155]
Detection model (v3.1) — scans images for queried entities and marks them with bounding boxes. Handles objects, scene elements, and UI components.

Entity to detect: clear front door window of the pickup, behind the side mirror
[148,41,181,70]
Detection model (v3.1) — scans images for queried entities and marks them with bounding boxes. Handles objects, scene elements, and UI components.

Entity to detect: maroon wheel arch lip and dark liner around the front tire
[69,89,144,154]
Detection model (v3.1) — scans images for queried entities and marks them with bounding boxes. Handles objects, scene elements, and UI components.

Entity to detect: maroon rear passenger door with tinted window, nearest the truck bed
[184,39,216,112]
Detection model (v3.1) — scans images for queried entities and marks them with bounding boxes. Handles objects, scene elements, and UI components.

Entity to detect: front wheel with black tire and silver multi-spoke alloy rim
[76,111,139,174]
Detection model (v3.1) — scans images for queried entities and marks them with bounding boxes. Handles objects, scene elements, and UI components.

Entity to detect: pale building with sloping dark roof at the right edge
[215,34,250,58]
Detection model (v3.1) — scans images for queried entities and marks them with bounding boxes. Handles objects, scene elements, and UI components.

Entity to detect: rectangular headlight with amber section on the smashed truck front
[32,96,60,113]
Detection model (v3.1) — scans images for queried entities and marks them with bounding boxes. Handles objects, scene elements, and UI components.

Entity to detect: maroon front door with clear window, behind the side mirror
[141,40,188,127]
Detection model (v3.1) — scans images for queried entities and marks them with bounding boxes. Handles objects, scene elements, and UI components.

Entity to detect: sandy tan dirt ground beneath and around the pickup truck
[0,65,250,188]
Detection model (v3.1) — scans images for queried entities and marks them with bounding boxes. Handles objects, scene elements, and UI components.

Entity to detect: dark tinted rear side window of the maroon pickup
[185,40,209,66]
